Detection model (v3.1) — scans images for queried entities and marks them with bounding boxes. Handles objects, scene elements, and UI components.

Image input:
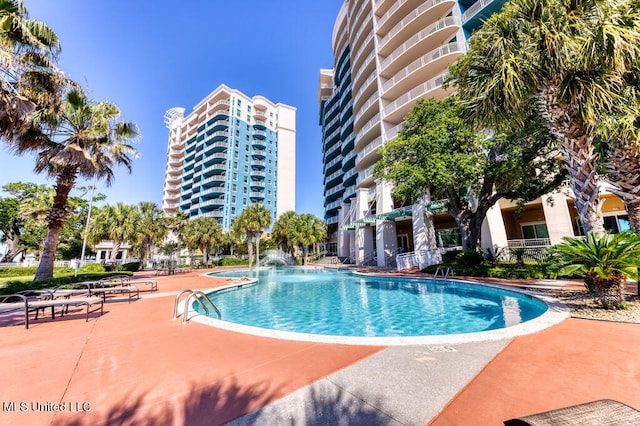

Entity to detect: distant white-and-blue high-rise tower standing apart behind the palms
[162,85,296,229]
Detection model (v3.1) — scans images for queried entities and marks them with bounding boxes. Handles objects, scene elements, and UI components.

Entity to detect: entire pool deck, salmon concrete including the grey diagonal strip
[0,271,640,425]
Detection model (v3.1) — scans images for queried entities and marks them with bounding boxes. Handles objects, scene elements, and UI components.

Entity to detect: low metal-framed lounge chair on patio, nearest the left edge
[0,292,104,329]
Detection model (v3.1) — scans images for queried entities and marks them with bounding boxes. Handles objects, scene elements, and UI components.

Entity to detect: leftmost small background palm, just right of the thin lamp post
[89,203,141,263]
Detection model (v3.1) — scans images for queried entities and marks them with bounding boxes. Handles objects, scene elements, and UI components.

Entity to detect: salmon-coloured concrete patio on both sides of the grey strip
[0,271,640,425]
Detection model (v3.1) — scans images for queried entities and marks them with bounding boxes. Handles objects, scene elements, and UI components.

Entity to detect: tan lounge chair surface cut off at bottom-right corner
[504,399,640,426]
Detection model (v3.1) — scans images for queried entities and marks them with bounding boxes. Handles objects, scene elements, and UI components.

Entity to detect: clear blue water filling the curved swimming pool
[202,268,547,337]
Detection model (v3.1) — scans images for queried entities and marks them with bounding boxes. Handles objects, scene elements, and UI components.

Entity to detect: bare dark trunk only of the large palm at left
[33,168,77,281]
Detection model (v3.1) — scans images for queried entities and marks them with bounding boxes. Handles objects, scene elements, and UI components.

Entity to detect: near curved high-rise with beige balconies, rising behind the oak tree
[318,0,625,266]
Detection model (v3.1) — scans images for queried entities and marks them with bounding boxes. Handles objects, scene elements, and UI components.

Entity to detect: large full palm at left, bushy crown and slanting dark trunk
[11,88,138,281]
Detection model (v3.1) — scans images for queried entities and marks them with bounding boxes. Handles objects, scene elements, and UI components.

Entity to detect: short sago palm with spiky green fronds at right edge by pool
[550,232,640,309]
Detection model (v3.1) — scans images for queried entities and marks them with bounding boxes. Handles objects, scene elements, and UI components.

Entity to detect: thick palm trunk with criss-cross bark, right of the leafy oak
[541,88,604,235]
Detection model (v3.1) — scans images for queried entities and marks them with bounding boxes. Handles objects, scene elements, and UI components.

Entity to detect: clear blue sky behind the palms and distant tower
[0,0,342,217]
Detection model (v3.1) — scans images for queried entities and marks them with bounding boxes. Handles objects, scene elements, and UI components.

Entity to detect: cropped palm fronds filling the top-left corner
[0,0,64,140]
